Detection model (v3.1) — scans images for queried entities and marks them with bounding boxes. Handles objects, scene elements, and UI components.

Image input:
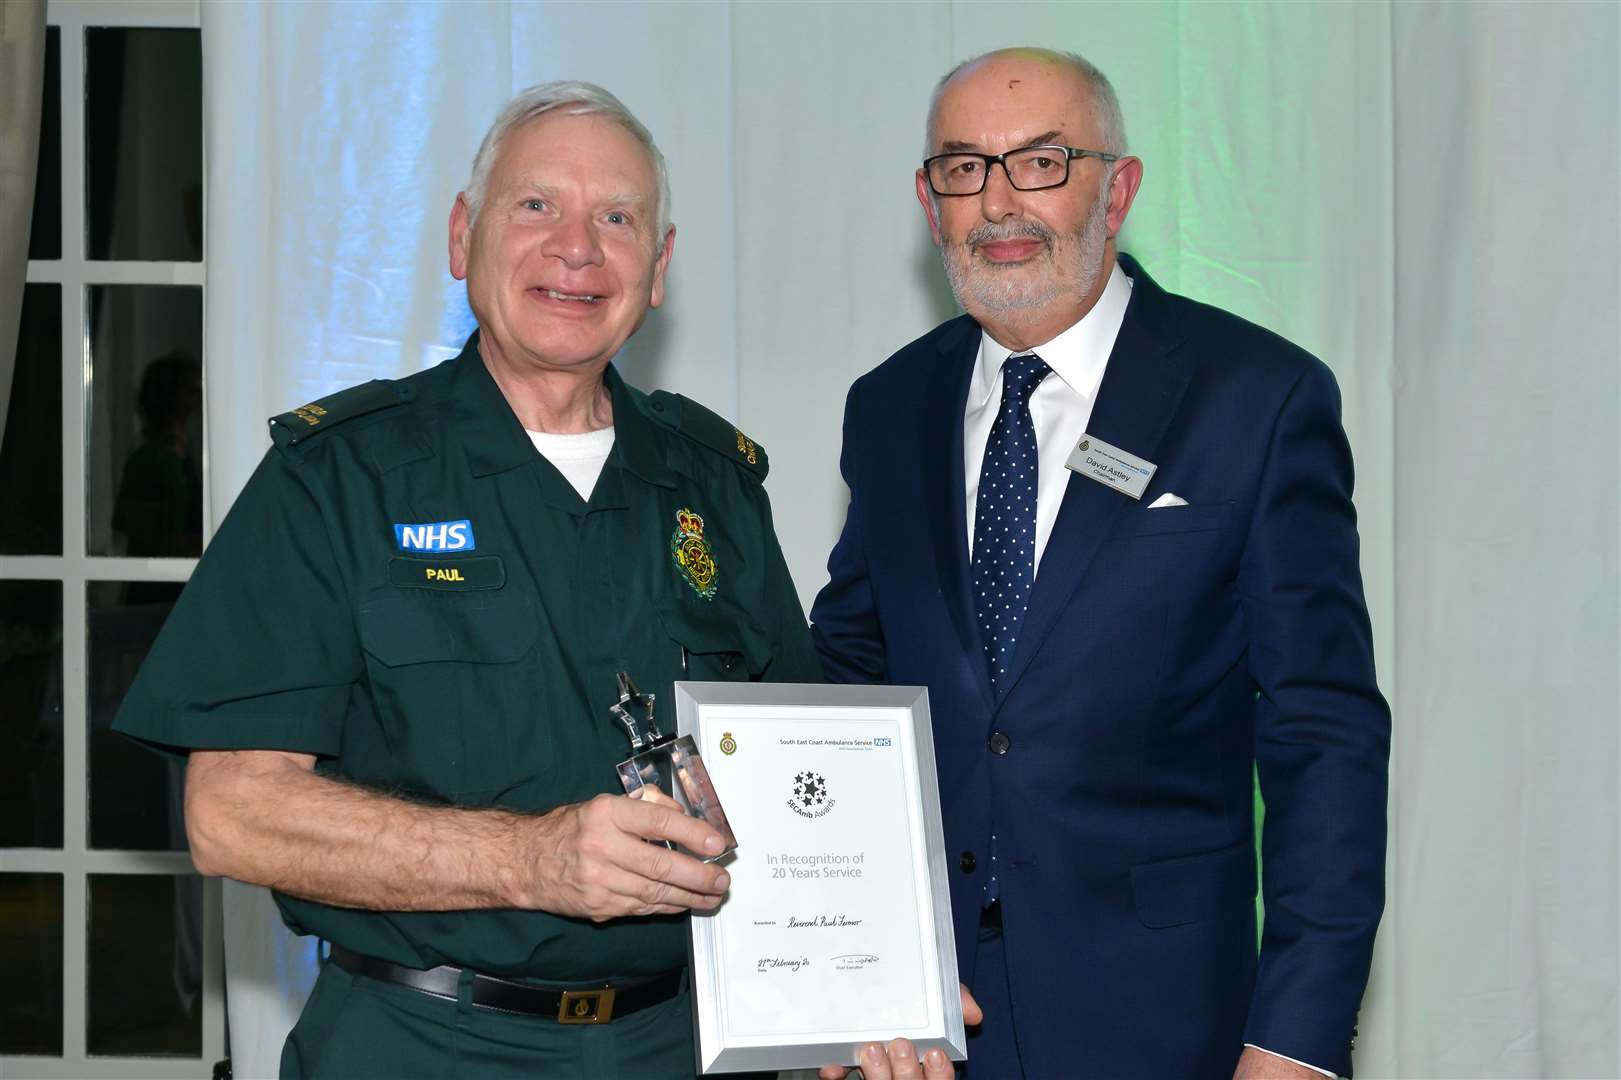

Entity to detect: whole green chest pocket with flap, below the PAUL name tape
[356,589,553,806]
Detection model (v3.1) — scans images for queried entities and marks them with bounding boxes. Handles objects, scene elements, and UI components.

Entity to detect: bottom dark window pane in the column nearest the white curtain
[84,874,203,1057]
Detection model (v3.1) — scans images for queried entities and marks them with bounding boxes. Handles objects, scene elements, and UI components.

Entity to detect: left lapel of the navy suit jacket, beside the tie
[922,316,990,707]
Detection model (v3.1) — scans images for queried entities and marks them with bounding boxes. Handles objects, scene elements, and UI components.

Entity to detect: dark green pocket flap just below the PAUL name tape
[358,590,535,668]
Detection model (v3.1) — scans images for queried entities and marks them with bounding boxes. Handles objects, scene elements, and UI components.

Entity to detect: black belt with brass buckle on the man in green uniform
[332,945,684,1023]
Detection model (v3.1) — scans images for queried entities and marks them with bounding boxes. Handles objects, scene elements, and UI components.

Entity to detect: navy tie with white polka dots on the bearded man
[973,354,1052,691]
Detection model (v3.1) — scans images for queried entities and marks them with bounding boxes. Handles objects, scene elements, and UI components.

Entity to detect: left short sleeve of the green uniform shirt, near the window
[113,449,363,756]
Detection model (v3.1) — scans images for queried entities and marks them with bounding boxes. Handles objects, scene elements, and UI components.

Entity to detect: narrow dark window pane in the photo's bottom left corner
[0,874,62,1056]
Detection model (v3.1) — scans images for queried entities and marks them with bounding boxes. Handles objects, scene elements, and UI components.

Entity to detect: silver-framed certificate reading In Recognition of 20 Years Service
[674,683,966,1074]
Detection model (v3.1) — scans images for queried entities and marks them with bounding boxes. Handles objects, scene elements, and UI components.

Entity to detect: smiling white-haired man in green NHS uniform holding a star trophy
[115,83,820,1077]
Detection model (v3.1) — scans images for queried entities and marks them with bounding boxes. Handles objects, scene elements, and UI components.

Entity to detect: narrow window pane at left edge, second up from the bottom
[0,581,63,843]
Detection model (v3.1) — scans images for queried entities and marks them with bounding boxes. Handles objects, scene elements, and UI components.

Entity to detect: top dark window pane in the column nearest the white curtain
[84,26,203,263]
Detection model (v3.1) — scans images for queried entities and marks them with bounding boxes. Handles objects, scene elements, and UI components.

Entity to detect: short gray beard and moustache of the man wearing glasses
[940,185,1109,321]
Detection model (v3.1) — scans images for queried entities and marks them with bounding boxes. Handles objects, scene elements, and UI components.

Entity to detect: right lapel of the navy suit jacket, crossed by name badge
[992,258,1190,701]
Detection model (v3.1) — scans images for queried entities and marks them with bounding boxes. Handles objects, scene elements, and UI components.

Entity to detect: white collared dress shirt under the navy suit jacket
[963,263,1131,568]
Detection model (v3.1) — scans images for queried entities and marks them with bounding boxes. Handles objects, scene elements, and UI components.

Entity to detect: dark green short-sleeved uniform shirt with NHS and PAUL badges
[113,336,820,981]
